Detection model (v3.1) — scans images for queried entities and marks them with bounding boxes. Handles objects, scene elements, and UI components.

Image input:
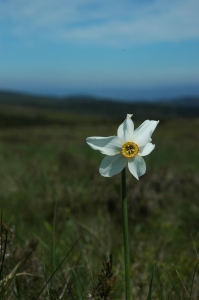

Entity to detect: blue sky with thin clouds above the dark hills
[0,0,199,99]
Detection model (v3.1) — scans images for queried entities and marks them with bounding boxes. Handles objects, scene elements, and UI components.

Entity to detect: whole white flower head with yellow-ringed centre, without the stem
[86,114,159,180]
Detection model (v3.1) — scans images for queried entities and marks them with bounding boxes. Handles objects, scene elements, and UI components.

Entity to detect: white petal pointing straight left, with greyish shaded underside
[86,136,122,155]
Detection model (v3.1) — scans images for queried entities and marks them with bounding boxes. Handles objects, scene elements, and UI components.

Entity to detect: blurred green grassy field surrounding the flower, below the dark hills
[0,108,199,300]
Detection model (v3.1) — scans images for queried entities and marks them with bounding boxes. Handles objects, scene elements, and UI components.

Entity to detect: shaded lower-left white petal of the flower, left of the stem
[99,154,127,177]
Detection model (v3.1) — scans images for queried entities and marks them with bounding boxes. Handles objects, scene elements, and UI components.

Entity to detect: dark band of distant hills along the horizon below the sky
[0,91,199,119]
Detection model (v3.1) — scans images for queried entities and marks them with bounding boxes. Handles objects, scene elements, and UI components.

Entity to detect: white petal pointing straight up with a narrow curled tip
[117,115,134,142]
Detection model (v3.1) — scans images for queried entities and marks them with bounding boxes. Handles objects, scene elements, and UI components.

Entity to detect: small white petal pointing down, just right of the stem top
[128,155,146,180]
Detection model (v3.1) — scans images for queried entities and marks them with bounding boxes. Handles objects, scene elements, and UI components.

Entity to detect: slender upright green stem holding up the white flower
[122,168,131,300]
